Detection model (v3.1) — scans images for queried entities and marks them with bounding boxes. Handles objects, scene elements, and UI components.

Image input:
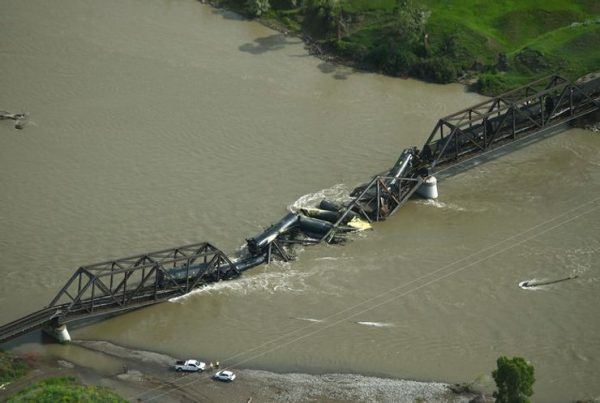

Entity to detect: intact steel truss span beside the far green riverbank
[419,75,600,170]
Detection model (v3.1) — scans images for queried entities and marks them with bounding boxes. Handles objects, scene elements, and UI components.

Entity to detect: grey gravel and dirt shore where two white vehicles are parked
[0,341,484,403]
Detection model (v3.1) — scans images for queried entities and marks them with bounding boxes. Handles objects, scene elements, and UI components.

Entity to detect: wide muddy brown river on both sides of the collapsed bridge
[0,0,600,402]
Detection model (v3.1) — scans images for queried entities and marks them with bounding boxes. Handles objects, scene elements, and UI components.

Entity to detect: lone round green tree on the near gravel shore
[492,356,535,403]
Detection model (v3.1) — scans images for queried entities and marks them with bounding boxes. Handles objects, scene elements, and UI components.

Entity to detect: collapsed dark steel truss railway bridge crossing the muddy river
[0,74,600,342]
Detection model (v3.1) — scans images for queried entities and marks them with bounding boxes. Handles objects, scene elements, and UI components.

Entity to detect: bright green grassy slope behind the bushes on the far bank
[425,0,600,95]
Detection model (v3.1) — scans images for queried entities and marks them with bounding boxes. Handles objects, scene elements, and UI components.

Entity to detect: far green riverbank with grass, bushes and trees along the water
[211,0,600,95]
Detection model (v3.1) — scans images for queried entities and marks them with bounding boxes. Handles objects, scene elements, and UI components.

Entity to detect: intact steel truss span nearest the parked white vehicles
[48,242,239,323]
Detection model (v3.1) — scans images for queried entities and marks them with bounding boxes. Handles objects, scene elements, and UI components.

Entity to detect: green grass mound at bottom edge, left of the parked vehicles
[8,377,127,403]
